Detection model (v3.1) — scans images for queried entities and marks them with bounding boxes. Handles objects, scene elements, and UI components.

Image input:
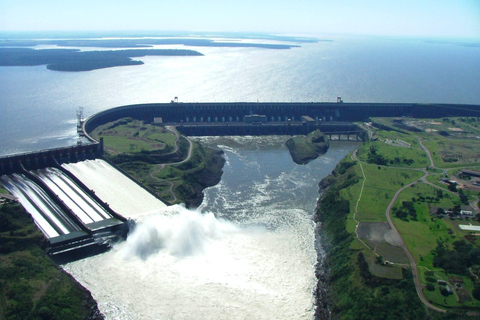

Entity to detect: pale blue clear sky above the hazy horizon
[0,0,480,40]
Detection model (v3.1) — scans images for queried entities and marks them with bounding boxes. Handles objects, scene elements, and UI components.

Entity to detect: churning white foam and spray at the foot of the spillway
[64,206,314,319]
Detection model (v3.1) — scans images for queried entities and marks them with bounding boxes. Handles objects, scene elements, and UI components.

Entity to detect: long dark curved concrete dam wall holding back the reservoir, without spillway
[83,102,480,135]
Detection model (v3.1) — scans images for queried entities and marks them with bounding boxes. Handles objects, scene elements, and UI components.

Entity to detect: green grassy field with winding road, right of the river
[326,118,480,311]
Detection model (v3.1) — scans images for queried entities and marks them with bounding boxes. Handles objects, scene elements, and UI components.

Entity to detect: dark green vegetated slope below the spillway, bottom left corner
[0,203,103,320]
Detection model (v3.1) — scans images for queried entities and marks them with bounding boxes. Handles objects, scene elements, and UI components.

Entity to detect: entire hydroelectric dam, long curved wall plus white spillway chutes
[0,99,480,254]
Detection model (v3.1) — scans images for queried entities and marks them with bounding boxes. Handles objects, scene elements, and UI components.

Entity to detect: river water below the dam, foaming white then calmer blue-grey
[63,136,358,319]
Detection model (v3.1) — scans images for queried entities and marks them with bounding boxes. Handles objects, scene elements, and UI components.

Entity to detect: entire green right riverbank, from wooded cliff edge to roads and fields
[315,118,480,319]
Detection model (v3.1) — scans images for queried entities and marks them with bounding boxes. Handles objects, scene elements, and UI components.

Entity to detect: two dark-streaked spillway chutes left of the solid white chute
[0,162,127,254]
